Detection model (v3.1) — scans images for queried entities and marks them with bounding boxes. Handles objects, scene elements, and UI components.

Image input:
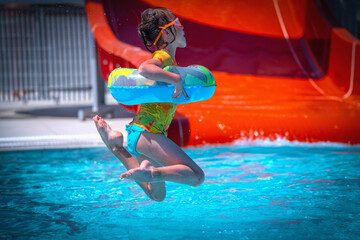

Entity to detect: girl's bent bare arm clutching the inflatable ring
[139,58,189,98]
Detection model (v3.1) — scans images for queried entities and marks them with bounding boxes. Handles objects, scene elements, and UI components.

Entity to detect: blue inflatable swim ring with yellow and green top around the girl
[108,65,216,105]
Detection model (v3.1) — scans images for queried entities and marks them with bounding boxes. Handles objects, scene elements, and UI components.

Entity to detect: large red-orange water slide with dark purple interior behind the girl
[86,0,360,146]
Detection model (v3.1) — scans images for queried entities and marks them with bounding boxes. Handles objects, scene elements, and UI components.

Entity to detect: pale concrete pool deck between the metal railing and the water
[0,97,133,151]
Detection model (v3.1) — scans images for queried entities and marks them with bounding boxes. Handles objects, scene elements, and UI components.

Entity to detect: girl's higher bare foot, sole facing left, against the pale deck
[93,115,124,150]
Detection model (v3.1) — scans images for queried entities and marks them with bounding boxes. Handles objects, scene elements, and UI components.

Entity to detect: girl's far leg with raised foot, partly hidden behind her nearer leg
[93,116,166,201]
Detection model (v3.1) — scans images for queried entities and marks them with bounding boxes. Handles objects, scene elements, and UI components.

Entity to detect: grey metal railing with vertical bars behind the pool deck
[0,5,96,102]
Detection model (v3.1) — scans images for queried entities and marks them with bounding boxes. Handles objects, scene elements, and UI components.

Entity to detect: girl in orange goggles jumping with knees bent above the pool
[93,8,204,201]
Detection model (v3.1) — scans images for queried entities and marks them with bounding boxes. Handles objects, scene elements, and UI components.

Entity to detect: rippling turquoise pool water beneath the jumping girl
[0,144,360,239]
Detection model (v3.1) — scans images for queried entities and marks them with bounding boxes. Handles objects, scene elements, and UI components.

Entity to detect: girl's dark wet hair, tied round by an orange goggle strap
[138,7,175,52]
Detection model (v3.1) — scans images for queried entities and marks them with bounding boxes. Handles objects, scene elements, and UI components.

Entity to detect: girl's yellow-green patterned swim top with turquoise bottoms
[126,51,177,155]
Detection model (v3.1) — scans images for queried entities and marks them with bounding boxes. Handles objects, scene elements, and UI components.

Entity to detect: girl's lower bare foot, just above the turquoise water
[120,160,158,183]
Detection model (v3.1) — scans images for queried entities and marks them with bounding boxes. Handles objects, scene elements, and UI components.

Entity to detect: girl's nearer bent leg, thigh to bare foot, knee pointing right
[121,132,204,187]
